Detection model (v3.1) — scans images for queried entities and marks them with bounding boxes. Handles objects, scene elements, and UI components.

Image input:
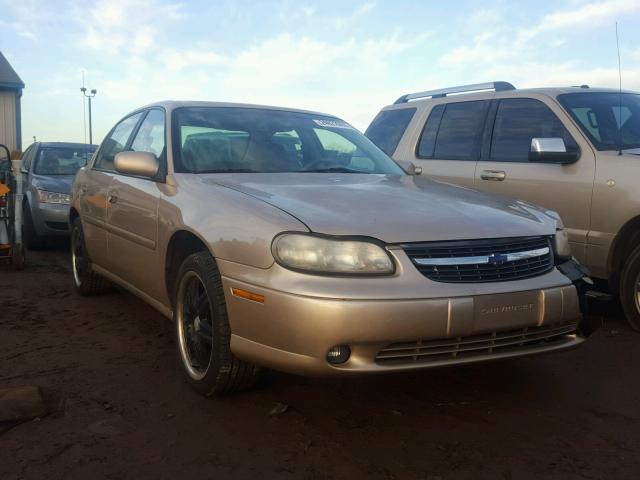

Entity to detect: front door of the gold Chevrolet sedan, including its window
[107,109,166,298]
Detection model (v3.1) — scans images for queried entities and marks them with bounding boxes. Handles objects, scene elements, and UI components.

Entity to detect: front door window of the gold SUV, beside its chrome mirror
[490,98,579,162]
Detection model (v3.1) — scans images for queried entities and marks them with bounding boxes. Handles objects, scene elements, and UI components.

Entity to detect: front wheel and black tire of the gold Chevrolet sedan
[174,252,260,396]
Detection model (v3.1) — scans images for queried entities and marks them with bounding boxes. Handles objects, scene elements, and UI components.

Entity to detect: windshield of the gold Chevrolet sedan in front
[173,107,405,175]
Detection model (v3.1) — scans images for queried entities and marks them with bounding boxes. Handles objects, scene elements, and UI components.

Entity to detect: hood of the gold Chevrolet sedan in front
[201,173,557,243]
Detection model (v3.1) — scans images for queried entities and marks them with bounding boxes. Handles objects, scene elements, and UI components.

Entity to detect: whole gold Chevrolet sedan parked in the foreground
[69,102,589,395]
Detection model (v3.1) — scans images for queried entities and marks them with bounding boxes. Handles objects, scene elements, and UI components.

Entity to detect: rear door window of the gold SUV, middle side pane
[418,100,488,160]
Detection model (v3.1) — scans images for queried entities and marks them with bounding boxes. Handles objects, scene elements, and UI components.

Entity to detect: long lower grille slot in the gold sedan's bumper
[376,322,577,364]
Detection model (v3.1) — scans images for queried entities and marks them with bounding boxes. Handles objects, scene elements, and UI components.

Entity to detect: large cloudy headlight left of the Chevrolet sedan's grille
[272,233,394,275]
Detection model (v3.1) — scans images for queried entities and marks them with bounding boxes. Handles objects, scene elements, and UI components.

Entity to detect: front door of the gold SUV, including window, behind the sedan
[476,98,595,262]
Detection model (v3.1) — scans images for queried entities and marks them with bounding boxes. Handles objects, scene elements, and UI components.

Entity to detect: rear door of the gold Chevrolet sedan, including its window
[76,113,142,270]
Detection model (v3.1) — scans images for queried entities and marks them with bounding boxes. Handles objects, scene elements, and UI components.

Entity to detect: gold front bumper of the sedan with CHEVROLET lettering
[222,256,584,376]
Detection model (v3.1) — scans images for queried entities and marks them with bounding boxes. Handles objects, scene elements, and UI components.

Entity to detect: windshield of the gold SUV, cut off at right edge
[558,92,640,150]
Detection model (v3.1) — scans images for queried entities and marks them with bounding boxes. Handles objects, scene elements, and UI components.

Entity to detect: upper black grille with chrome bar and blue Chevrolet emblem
[402,237,553,283]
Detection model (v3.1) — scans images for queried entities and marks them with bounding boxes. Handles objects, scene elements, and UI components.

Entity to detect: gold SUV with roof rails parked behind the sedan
[366,82,640,329]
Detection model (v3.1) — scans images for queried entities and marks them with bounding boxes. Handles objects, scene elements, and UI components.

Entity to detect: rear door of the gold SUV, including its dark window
[411,100,489,187]
